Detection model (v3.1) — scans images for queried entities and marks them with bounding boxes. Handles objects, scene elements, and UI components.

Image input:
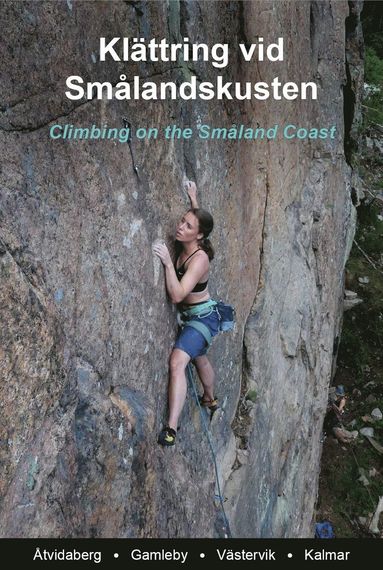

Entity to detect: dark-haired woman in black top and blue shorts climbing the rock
[153,181,220,446]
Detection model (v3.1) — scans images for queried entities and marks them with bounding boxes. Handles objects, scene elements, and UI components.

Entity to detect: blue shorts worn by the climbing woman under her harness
[174,307,219,359]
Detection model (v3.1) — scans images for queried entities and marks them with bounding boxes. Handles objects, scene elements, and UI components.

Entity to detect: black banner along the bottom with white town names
[0,538,383,570]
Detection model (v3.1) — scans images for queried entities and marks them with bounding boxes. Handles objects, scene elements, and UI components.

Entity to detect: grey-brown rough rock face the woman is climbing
[0,0,360,537]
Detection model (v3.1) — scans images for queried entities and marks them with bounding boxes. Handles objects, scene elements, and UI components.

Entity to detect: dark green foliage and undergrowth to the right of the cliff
[320,2,383,538]
